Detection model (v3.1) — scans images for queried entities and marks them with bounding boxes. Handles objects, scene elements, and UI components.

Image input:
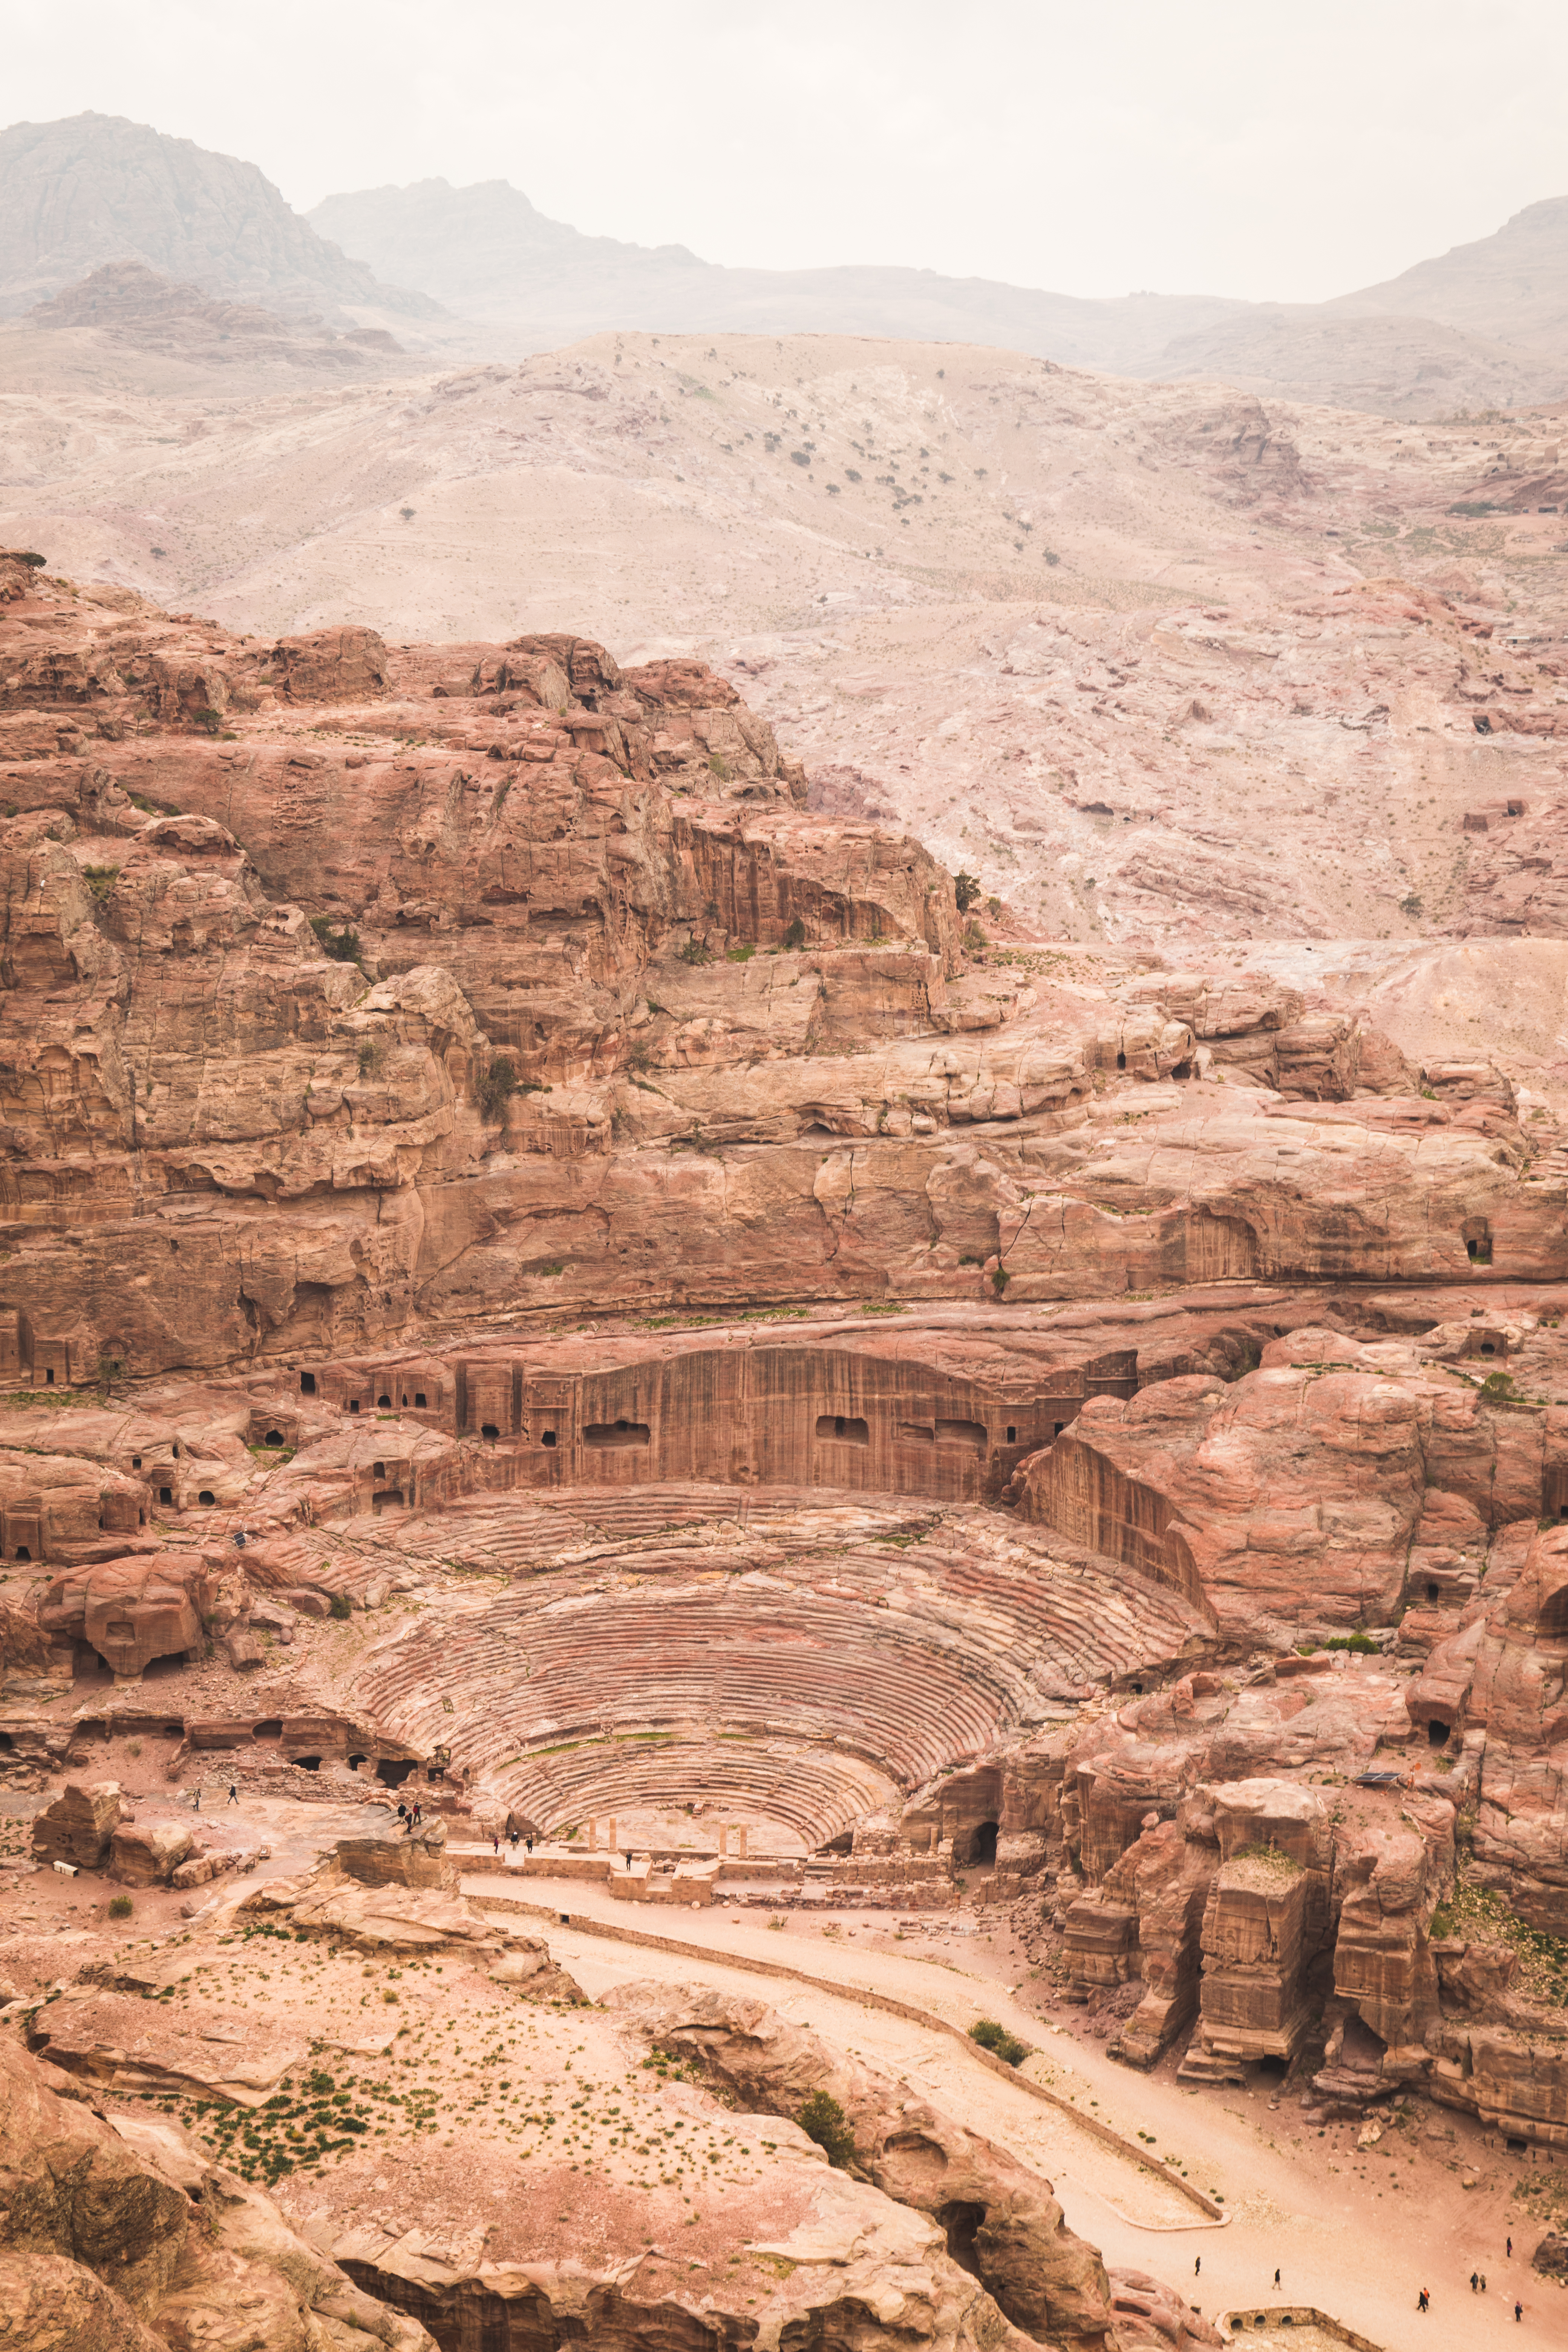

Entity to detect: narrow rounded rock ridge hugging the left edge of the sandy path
[606,1983,1110,2345]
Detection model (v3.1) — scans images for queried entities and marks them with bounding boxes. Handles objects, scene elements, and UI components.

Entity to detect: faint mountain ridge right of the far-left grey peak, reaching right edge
[310,179,1568,414]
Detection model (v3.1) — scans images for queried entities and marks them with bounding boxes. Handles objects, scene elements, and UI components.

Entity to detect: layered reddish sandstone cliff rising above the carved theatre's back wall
[0,565,1568,1385]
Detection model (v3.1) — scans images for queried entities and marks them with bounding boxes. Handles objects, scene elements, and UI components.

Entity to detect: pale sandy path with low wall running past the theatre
[463,1872,1568,2352]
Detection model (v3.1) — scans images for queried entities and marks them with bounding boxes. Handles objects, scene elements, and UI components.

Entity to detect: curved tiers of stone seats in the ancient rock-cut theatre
[353,1489,1204,1844]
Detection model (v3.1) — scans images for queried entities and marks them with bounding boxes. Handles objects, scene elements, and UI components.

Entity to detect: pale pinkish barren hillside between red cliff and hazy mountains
[5,325,1568,992]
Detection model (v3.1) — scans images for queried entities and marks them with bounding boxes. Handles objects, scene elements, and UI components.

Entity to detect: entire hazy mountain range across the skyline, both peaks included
[0,113,1568,419]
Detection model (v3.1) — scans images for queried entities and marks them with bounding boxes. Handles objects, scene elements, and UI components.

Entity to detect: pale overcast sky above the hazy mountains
[0,0,1568,301]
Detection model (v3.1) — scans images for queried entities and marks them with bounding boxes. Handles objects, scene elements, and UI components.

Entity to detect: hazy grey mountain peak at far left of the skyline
[0,113,442,325]
